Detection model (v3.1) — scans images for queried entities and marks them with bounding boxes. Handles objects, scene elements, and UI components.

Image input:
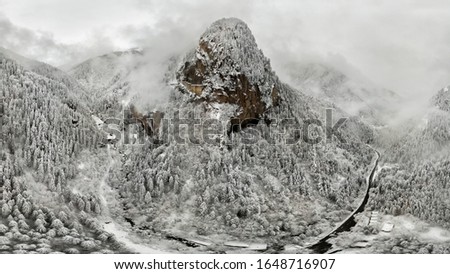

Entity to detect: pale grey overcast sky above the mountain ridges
[0,0,450,98]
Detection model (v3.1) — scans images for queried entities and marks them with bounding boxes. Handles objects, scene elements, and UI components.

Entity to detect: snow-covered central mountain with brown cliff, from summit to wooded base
[115,18,374,244]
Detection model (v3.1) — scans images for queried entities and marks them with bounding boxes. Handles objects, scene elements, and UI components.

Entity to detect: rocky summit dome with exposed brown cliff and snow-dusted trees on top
[178,18,280,130]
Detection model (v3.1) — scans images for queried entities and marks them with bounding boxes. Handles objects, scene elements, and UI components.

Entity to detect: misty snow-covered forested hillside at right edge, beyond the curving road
[370,88,450,235]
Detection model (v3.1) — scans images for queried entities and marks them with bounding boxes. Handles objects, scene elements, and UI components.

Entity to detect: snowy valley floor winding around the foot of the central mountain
[59,148,450,254]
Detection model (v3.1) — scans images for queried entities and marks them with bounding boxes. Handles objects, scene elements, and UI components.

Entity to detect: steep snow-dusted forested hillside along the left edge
[0,54,126,253]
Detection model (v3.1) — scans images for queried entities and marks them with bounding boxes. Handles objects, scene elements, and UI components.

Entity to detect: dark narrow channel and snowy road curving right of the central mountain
[308,147,381,253]
